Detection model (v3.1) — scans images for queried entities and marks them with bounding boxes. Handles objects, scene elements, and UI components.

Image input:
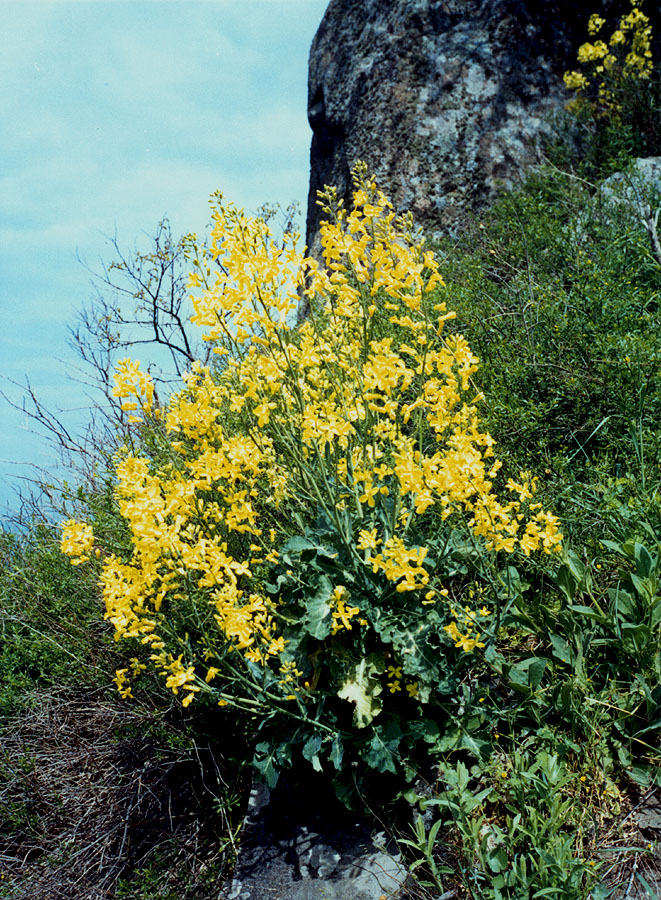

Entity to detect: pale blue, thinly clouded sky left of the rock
[0,0,328,507]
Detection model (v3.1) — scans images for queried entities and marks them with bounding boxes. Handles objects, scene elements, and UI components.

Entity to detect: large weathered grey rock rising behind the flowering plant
[307,0,612,252]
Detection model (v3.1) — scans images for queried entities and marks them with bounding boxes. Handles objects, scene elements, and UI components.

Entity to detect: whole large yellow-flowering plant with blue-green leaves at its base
[62,165,562,783]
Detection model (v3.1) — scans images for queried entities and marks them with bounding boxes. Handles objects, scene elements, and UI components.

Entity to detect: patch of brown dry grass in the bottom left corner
[0,691,237,900]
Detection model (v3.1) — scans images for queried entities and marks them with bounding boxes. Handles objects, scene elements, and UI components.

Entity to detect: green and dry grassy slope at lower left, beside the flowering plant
[0,522,248,900]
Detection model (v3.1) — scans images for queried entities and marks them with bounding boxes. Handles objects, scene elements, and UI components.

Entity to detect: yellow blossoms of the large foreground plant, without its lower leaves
[62,169,562,705]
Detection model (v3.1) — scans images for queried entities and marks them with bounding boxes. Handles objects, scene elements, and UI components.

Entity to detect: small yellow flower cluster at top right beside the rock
[564,0,653,114]
